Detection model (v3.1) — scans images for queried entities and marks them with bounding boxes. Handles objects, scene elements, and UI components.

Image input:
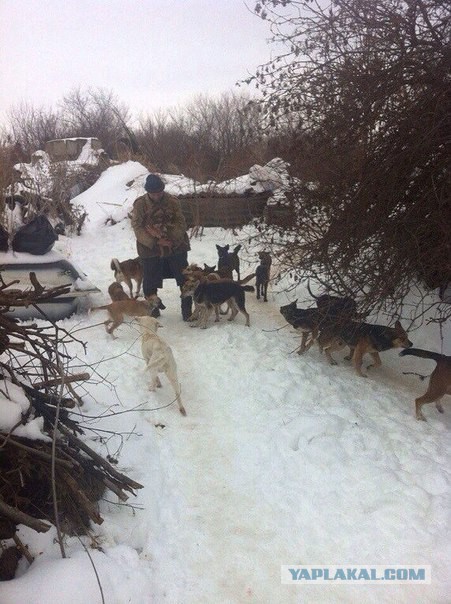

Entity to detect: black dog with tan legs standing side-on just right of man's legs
[182,279,255,329]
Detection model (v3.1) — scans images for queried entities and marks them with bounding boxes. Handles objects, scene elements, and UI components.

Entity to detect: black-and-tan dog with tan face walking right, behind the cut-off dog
[319,321,413,377]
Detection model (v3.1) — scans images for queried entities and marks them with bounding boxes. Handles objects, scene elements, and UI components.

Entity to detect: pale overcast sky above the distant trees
[0,0,271,126]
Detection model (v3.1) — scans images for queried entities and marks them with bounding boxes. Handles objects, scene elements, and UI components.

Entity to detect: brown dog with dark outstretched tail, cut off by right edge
[399,348,451,421]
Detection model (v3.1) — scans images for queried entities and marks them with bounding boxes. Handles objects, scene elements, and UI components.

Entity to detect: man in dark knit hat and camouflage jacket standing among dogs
[132,174,192,321]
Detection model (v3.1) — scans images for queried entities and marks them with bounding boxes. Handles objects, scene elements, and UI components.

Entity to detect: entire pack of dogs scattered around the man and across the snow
[92,245,451,421]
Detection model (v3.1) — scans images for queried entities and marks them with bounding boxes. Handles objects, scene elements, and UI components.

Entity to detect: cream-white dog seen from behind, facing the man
[136,316,186,415]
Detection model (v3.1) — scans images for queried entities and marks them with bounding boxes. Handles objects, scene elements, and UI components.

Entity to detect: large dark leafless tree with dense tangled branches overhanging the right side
[249,0,451,326]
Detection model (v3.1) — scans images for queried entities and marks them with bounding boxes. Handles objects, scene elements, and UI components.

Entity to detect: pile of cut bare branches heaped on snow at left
[0,273,142,579]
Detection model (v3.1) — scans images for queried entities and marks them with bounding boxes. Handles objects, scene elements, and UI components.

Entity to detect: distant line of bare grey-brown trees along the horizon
[2,89,288,181]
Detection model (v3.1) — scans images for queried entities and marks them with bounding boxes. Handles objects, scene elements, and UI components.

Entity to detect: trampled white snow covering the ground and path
[0,162,451,604]
